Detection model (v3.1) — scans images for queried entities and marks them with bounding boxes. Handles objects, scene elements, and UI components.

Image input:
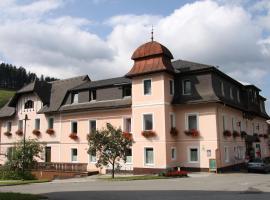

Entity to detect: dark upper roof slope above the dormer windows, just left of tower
[71,77,131,91]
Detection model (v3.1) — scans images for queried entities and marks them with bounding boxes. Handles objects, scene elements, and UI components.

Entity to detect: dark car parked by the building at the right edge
[247,158,270,173]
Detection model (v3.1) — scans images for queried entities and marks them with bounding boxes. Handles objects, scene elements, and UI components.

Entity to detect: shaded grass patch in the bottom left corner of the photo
[0,192,48,200]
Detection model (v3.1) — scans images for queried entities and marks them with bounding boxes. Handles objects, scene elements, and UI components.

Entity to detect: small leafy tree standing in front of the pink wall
[88,123,133,178]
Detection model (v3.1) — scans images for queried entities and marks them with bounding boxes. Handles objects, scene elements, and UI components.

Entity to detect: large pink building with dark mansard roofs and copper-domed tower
[0,41,270,174]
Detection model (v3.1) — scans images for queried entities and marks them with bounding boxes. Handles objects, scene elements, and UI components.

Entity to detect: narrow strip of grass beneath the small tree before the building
[99,175,171,181]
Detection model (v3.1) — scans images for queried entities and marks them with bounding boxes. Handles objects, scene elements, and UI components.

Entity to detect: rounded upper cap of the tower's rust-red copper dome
[131,41,173,60]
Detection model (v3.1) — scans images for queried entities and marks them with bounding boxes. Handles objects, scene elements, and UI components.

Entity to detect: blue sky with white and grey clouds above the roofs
[0,0,270,113]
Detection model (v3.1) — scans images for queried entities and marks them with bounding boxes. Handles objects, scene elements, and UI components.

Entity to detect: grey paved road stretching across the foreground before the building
[0,173,270,200]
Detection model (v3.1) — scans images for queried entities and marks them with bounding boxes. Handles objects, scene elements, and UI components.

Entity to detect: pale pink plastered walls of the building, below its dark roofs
[0,40,270,173]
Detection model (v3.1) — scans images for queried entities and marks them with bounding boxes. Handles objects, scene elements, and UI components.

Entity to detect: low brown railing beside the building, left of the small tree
[33,162,87,172]
